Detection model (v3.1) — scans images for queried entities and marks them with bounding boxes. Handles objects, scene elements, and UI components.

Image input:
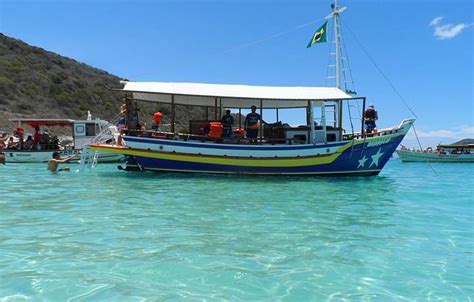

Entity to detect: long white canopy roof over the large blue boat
[122,82,351,108]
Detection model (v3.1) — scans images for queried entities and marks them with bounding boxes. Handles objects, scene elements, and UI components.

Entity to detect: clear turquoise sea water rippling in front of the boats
[0,159,474,301]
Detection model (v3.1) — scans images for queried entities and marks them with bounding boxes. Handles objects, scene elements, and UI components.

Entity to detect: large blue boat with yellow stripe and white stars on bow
[89,3,415,176]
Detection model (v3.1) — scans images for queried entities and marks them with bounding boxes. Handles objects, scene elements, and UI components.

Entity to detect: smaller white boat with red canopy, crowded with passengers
[3,118,123,163]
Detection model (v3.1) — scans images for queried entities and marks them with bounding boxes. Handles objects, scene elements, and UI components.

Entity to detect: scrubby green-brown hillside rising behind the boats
[0,34,211,131]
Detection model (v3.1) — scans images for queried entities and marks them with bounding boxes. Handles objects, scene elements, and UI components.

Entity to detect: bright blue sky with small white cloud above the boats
[0,0,474,146]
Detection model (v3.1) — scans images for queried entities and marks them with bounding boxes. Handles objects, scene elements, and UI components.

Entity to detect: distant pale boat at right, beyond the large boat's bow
[396,140,474,163]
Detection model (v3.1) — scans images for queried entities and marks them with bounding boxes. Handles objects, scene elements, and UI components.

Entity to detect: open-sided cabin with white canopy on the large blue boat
[121,82,379,144]
